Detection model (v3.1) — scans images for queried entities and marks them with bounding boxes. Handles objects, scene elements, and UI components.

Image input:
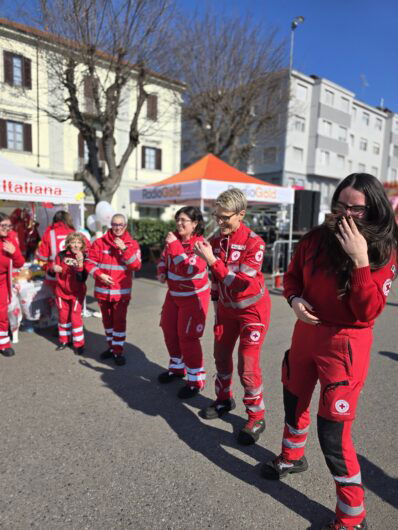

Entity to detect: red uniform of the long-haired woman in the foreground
[282,231,396,527]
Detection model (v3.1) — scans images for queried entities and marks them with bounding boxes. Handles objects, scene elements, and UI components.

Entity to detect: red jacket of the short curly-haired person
[55,250,87,301]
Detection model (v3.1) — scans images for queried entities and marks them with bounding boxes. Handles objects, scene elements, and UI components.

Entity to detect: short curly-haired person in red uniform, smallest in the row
[53,232,87,355]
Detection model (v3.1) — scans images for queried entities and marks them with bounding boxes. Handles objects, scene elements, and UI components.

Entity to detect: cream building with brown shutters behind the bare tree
[0,19,183,217]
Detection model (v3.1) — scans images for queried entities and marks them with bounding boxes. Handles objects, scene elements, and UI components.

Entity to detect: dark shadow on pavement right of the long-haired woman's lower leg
[358,455,398,508]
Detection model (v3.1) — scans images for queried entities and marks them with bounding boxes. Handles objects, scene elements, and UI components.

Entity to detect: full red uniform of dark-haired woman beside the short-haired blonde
[158,234,210,389]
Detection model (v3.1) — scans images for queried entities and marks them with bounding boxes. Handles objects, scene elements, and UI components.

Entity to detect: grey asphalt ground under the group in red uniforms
[0,278,398,530]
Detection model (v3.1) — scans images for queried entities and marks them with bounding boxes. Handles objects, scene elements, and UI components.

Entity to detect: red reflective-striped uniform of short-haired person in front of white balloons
[86,230,141,355]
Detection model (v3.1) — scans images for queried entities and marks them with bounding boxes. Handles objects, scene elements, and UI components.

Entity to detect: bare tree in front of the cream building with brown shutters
[33,0,177,202]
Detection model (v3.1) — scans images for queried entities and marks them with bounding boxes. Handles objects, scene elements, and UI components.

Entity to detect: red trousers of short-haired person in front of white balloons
[97,299,130,355]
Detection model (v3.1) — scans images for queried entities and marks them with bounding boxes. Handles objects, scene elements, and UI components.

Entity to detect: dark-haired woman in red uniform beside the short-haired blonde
[158,206,210,399]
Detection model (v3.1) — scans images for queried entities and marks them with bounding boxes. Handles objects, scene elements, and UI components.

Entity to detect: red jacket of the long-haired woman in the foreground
[283,232,397,328]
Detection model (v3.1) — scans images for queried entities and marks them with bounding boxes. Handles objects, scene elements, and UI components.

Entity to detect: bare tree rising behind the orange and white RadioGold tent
[173,9,287,164]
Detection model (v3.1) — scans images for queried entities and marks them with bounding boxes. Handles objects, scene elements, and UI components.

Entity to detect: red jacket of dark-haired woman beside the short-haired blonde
[158,234,209,296]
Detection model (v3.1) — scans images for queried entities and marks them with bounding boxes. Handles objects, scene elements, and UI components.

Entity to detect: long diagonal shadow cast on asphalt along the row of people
[80,331,333,528]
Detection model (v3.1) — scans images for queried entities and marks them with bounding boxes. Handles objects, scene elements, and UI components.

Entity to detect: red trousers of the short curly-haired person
[56,296,84,348]
